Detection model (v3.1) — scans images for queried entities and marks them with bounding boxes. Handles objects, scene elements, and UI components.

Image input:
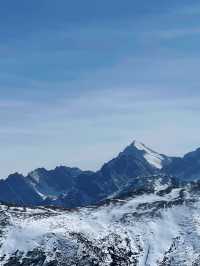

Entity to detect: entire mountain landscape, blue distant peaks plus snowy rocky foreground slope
[0,141,200,266]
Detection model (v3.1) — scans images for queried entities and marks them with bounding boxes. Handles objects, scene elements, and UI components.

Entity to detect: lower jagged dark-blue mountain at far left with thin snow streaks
[0,166,82,205]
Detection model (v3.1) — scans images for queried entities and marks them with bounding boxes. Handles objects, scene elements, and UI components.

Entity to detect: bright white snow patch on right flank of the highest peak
[132,140,165,169]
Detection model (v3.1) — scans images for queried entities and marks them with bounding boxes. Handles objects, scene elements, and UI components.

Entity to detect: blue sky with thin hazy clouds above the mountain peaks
[0,0,200,177]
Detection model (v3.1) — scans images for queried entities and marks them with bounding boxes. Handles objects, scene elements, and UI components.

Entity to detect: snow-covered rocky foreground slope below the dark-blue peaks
[0,176,200,266]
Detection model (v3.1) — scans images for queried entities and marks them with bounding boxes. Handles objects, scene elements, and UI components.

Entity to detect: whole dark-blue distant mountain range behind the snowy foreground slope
[0,141,200,208]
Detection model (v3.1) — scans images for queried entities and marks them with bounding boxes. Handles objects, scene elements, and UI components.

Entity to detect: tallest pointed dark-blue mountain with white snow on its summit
[48,141,172,207]
